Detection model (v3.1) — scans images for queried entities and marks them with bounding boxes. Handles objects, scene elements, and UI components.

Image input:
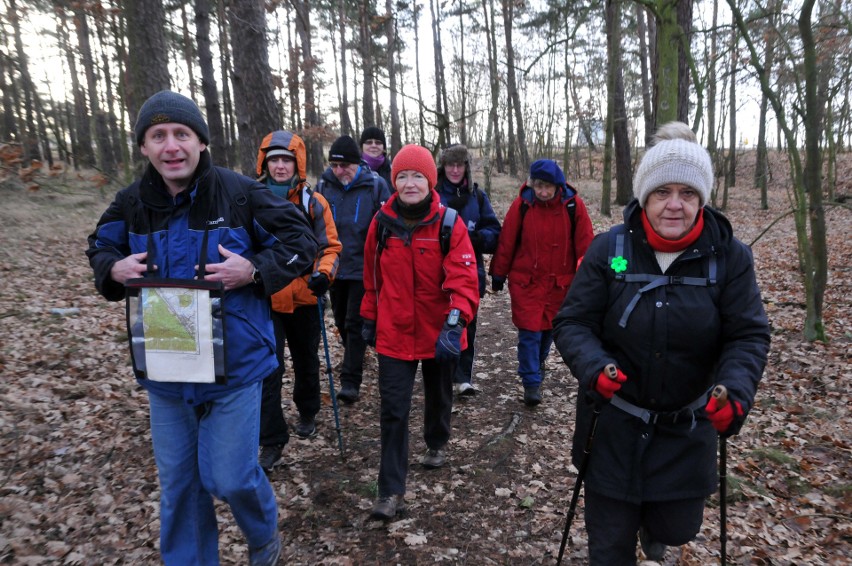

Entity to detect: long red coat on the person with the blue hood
[490,184,594,332]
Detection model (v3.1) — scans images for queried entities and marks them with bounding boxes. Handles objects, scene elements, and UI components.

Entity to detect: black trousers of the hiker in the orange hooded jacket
[260,305,320,446]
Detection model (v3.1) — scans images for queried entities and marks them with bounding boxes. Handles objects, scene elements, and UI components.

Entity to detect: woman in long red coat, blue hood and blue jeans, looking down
[491,159,594,407]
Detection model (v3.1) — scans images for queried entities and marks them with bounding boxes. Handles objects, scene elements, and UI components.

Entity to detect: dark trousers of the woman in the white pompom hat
[584,491,704,566]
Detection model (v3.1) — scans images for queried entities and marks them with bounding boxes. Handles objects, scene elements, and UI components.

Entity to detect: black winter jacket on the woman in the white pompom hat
[554,200,769,502]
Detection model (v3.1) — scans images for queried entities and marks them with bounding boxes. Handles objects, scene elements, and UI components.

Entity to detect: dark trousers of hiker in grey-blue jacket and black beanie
[330,279,367,389]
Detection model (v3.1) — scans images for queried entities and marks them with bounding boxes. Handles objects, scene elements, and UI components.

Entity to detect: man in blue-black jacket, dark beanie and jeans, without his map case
[86,91,317,566]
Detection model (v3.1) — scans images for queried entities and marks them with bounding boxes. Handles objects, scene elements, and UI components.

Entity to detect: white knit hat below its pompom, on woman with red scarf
[633,139,713,207]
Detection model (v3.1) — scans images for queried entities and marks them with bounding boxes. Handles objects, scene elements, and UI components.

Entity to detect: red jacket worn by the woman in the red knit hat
[361,190,479,360]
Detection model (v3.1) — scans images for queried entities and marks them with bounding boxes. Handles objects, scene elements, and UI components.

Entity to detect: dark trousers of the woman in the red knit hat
[379,354,455,497]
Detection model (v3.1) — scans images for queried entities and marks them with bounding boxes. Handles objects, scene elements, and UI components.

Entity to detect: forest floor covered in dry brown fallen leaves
[0,153,852,566]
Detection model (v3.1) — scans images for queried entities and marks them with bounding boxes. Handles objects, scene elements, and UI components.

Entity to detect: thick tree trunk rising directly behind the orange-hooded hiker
[228,0,281,176]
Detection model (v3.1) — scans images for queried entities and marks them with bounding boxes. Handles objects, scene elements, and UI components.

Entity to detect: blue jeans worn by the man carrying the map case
[148,382,278,566]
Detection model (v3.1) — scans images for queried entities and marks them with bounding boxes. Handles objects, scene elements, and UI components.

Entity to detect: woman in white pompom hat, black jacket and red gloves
[554,122,769,565]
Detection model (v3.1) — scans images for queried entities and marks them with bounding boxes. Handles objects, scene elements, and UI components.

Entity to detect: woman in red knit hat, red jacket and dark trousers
[361,145,479,520]
